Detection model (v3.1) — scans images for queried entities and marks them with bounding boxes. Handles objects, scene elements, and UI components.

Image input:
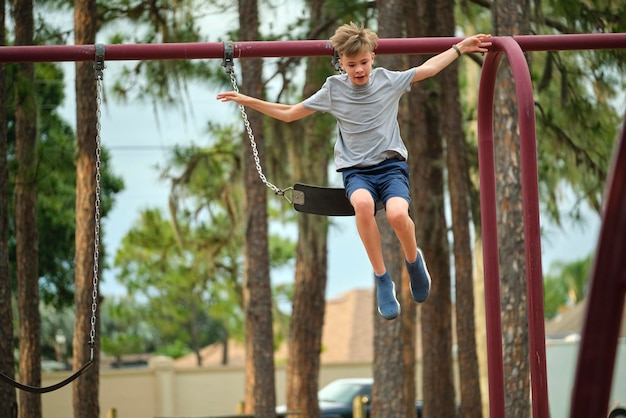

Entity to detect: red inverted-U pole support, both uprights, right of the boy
[478,37,549,418]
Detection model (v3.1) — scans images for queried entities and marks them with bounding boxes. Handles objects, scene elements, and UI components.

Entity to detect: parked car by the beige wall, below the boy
[276,378,422,418]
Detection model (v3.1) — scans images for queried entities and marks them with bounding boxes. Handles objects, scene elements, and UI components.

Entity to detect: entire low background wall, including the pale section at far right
[42,339,626,418]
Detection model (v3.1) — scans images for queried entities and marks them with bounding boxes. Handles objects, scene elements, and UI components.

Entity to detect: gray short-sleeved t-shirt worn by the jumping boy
[302,68,415,170]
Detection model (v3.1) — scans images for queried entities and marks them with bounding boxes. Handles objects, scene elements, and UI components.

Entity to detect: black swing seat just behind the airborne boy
[292,183,384,216]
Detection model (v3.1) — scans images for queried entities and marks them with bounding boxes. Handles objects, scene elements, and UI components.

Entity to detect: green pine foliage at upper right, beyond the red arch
[457,0,626,229]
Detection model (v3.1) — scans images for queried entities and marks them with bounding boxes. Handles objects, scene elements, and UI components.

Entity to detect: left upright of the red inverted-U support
[478,53,505,417]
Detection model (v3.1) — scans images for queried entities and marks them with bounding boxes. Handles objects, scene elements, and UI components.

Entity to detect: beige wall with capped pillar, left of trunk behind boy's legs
[42,357,372,418]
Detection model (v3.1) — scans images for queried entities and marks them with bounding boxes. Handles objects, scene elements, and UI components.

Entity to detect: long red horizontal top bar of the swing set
[0,33,626,62]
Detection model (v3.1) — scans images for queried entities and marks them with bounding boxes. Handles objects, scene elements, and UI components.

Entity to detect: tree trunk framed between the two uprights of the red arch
[492,0,530,417]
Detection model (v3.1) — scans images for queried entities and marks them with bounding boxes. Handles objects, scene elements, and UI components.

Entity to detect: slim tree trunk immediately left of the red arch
[437,0,482,418]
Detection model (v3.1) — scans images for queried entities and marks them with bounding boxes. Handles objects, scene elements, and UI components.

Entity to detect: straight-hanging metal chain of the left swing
[89,44,104,360]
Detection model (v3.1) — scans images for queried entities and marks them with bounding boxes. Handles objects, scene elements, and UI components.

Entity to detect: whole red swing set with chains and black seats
[0,33,626,418]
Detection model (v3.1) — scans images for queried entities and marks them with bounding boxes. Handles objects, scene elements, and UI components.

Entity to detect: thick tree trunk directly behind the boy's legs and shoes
[372,0,416,417]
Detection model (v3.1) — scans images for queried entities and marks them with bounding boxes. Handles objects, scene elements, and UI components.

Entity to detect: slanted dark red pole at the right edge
[570,118,626,418]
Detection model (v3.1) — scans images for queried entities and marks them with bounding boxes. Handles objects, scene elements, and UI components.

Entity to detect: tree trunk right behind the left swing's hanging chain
[72,0,100,418]
